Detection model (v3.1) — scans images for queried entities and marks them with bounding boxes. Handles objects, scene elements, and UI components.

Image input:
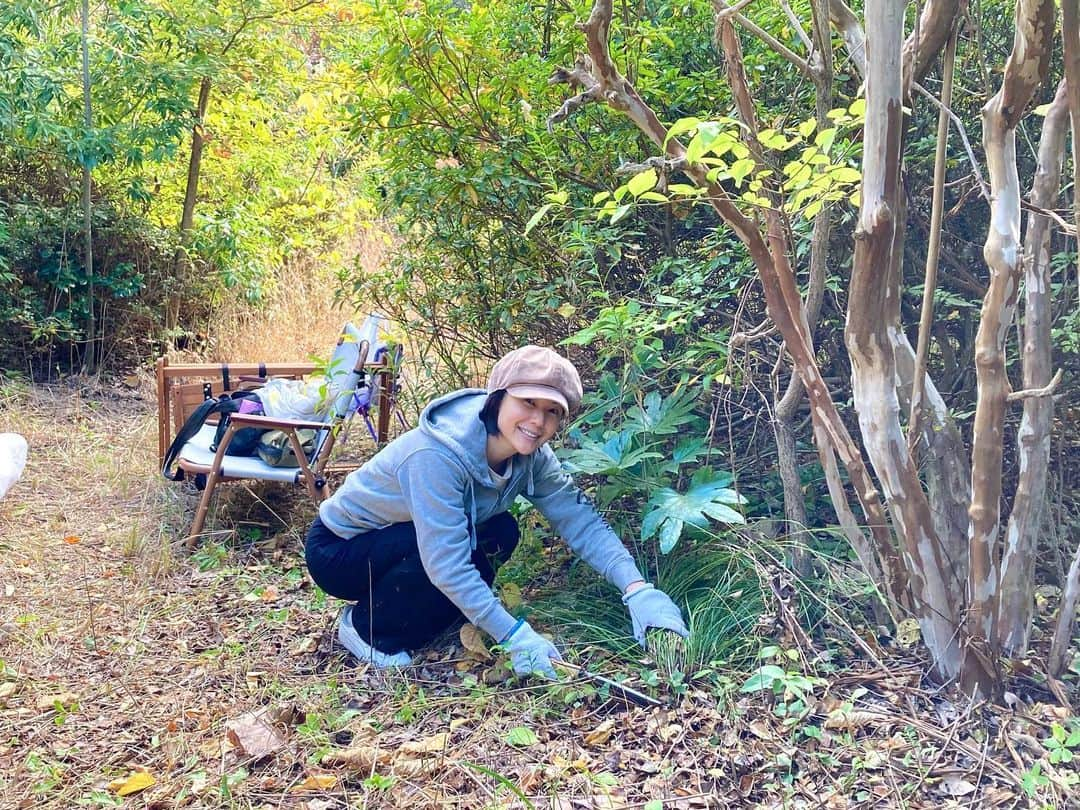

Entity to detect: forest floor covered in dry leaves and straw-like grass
[0,378,1080,810]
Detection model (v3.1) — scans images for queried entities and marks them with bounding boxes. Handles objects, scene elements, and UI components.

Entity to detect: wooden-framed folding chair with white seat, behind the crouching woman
[157,315,397,549]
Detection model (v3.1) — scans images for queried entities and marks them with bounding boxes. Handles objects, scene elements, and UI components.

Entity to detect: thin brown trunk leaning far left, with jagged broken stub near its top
[549,0,907,604]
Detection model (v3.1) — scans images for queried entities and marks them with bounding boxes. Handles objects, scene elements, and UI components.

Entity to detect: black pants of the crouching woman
[305,512,521,653]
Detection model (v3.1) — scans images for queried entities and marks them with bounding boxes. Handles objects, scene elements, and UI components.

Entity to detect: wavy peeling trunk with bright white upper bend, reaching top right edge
[961,0,1054,694]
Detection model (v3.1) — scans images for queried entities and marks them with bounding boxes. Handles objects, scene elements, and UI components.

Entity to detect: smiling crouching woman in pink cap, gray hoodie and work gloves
[306,346,689,678]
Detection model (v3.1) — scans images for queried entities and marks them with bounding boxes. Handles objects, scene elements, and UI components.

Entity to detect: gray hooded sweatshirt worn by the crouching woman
[319,389,642,640]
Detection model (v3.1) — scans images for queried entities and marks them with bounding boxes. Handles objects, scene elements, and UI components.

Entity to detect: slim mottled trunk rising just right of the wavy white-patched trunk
[998,82,1069,654]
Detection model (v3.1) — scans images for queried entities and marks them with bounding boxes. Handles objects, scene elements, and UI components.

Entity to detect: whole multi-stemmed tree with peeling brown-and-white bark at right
[551,0,1075,696]
